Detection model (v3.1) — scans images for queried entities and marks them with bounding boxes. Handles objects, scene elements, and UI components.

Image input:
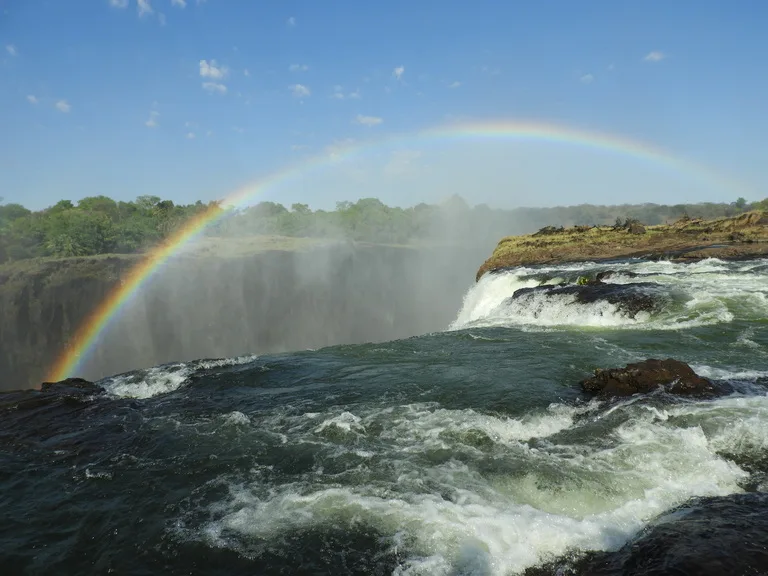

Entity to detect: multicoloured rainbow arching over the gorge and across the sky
[49,120,733,381]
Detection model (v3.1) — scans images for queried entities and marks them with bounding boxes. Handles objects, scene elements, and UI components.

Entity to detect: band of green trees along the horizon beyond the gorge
[0,196,768,263]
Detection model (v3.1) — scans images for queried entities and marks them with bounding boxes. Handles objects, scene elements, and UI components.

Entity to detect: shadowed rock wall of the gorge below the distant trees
[0,241,485,390]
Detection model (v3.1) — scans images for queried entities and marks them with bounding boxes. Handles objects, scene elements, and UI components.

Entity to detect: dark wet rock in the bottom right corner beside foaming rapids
[525,493,768,576]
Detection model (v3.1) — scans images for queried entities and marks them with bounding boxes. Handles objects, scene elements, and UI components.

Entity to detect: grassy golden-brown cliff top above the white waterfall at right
[476,210,768,280]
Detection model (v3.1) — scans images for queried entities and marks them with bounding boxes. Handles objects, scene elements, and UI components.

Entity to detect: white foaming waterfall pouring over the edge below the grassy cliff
[449,259,768,330]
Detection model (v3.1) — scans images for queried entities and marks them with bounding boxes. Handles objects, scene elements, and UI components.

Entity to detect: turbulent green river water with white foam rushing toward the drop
[0,260,768,575]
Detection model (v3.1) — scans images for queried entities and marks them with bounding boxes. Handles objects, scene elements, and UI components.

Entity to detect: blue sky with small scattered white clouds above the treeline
[0,0,768,208]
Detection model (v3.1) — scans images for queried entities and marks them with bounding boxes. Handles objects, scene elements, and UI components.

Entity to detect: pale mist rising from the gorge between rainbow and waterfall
[77,206,504,379]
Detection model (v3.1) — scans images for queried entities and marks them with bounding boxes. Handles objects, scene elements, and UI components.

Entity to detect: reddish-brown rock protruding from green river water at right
[581,358,717,396]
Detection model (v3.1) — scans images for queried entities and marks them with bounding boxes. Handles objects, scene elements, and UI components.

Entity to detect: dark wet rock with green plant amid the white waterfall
[511,281,664,318]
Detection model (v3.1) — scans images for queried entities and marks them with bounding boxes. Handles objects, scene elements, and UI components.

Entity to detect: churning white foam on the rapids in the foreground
[186,397,768,575]
